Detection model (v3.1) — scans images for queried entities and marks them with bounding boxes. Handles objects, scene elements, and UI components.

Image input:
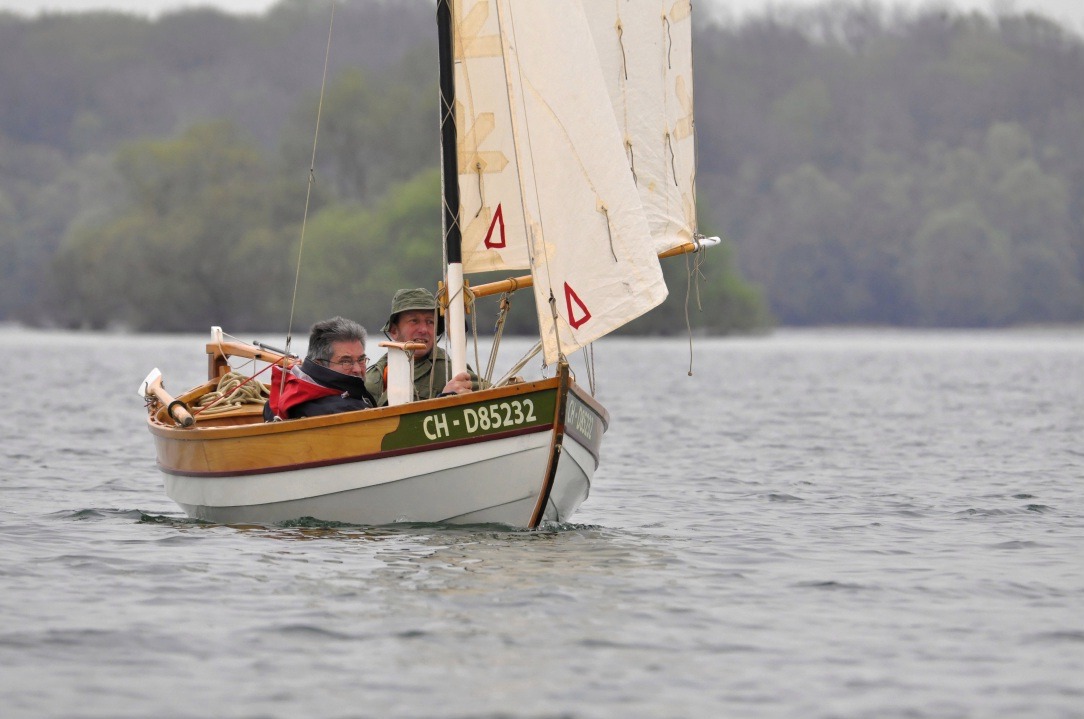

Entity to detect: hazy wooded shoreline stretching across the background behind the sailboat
[0,0,1084,333]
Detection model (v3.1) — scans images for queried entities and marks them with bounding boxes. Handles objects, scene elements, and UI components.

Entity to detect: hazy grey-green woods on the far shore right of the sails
[697,4,1084,326]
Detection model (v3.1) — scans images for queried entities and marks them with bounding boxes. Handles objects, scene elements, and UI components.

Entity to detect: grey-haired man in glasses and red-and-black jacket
[263,317,376,422]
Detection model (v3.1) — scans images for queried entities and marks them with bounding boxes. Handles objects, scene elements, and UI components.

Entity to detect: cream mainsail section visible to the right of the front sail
[583,0,697,252]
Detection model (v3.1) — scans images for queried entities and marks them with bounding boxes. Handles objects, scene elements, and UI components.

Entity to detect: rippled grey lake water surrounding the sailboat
[0,329,1084,719]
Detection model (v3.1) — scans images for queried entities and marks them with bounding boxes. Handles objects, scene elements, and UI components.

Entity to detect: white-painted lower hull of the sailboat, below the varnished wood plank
[165,433,595,527]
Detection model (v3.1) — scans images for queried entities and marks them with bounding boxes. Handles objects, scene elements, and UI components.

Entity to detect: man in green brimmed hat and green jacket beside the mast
[365,287,481,407]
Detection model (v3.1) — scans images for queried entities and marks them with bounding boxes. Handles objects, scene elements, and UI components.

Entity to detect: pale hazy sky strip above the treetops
[0,0,1084,33]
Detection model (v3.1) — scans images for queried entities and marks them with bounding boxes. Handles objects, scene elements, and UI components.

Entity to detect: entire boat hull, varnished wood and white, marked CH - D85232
[150,369,607,528]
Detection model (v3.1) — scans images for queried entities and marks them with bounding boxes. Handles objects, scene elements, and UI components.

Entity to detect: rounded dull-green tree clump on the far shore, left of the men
[54,123,286,331]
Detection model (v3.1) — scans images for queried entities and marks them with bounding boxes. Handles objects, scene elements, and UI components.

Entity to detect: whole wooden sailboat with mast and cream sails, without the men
[140,0,712,528]
